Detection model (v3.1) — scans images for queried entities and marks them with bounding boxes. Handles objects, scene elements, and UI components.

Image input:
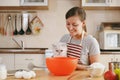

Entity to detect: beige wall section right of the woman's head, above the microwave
[86,10,120,39]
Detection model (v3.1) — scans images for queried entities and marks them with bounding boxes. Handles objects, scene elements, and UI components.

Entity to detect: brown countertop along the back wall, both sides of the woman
[0,48,120,55]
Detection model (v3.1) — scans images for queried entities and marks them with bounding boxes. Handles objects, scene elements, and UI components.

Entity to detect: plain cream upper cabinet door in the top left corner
[0,0,19,6]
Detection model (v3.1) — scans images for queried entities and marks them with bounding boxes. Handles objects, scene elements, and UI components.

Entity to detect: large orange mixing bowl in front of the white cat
[46,57,78,76]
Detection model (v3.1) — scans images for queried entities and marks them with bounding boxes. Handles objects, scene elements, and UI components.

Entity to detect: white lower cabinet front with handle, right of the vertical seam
[15,54,44,69]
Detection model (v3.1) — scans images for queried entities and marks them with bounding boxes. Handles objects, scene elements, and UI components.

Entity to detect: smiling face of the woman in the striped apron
[66,16,84,37]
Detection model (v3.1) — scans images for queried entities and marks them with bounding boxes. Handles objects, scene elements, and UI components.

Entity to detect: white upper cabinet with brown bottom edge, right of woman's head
[81,0,120,9]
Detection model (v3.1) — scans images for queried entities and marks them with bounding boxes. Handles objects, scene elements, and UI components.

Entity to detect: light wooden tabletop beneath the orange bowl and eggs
[6,70,104,80]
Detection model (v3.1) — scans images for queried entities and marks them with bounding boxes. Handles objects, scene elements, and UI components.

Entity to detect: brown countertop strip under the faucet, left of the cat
[0,48,45,53]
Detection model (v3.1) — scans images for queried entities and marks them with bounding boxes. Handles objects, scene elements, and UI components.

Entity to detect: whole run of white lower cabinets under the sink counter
[0,53,45,70]
